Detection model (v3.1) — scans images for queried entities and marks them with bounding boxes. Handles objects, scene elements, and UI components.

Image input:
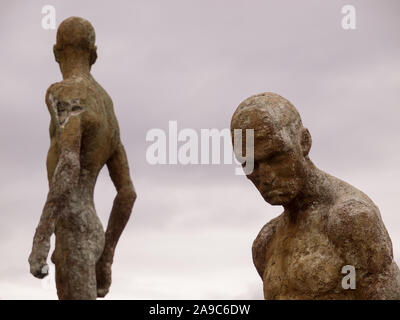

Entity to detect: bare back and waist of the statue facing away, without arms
[46,76,119,263]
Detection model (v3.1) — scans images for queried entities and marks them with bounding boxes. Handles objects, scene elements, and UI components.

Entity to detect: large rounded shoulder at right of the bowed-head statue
[328,200,393,273]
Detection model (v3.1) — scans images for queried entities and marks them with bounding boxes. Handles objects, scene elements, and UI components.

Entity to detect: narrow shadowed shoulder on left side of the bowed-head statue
[252,214,282,278]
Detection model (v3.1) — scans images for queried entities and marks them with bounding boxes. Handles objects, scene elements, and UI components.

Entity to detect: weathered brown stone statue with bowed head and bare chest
[231,93,400,299]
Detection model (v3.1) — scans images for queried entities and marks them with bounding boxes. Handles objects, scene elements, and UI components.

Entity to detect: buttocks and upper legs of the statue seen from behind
[54,205,104,300]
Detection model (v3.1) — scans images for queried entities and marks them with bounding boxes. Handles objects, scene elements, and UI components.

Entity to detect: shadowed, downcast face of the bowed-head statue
[234,112,305,205]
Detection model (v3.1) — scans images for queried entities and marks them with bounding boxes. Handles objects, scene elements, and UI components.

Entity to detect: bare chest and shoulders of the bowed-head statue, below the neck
[253,175,400,299]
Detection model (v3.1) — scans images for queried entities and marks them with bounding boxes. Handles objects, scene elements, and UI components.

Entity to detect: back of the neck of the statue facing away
[60,50,90,80]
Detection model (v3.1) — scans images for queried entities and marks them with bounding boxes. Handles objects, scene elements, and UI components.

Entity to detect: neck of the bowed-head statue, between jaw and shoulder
[283,159,331,219]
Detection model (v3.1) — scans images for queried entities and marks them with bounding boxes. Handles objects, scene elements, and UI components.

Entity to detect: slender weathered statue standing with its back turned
[29,17,136,299]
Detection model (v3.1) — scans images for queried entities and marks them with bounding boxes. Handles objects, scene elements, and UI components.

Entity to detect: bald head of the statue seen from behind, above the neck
[54,17,97,65]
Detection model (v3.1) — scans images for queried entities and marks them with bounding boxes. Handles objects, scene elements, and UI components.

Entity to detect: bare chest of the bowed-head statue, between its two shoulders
[263,208,350,299]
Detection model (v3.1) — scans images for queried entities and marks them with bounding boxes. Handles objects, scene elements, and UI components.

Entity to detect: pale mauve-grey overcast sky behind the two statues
[0,0,400,299]
